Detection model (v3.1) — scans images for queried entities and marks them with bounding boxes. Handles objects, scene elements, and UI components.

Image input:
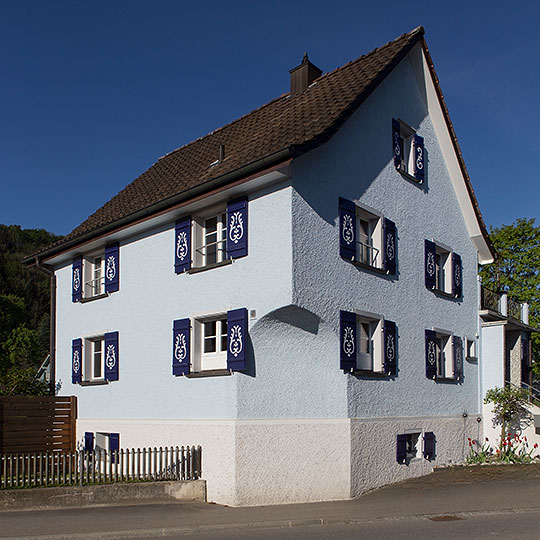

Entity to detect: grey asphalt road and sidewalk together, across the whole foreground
[0,465,540,540]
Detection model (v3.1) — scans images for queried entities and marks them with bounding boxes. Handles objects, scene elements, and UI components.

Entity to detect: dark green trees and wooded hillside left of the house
[0,221,60,395]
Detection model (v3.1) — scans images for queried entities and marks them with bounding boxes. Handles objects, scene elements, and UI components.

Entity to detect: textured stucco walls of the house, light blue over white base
[57,48,481,505]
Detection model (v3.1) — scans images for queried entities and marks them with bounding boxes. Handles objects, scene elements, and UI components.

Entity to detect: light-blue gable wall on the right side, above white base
[292,45,478,417]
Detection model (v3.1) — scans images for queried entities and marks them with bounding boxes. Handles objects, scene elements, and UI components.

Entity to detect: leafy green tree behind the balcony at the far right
[480,218,540,375]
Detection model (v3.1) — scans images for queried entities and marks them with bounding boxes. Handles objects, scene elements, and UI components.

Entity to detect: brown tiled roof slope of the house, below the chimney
[28,27,494,256]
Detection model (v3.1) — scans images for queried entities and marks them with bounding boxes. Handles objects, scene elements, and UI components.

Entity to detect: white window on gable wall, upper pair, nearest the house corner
[355,203,383,269]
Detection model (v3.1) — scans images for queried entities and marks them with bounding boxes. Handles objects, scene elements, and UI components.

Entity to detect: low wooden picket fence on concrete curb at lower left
[0,446,202,489]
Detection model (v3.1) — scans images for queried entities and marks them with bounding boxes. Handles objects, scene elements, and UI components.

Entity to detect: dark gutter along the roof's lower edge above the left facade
[21,147,296,264]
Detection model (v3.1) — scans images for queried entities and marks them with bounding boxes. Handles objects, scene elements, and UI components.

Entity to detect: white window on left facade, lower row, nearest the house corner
[191,312,227,372]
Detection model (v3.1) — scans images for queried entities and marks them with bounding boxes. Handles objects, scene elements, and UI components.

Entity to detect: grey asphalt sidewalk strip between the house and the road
[0,465,540,539]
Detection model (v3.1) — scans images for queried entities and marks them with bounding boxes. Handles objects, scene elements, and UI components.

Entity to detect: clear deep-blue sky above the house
[0,0,540,234]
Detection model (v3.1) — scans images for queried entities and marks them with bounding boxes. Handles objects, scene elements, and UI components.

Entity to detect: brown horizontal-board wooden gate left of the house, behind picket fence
[0,396,77,454]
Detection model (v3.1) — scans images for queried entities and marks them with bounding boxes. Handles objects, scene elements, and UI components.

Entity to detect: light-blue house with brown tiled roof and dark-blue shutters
[28,28,494,505]
